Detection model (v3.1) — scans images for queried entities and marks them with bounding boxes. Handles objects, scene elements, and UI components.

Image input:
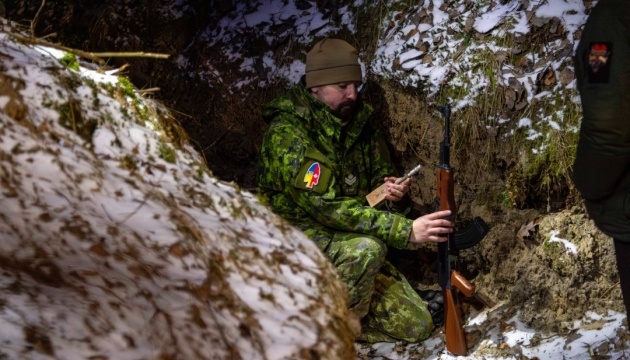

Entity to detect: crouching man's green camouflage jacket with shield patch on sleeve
[257,84,412,249]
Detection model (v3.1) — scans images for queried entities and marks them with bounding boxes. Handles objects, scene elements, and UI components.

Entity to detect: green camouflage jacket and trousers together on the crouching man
[257,84,433,342]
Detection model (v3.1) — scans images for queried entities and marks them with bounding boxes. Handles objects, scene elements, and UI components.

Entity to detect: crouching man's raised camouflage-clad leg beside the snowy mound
[324,233,387,318]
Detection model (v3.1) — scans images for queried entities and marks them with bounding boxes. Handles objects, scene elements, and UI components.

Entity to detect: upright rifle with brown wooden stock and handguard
[435,104,476,355]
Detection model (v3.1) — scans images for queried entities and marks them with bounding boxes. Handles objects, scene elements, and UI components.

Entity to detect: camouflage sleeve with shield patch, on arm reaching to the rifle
[259,119,412,248]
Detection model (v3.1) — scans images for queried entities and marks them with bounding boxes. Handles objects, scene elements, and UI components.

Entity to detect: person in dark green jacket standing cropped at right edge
[573,0,630,314]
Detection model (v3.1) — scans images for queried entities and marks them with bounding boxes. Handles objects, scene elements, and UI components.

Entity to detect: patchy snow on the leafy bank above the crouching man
[196,0,587,163]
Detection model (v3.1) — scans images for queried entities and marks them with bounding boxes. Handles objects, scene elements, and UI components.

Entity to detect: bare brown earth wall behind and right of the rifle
[370,79,627,354]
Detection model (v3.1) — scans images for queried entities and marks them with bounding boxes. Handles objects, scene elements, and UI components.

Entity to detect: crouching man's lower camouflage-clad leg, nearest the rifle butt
[359,262,433,343]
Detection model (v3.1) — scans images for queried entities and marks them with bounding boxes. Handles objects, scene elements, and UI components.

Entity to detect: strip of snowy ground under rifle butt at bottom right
[357,304,630,360]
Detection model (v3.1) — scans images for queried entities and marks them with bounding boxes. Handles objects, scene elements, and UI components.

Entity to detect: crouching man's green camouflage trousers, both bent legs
[322,233,433,343]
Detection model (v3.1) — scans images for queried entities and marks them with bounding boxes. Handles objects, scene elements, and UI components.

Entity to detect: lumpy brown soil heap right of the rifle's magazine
[404,205,623,333]
